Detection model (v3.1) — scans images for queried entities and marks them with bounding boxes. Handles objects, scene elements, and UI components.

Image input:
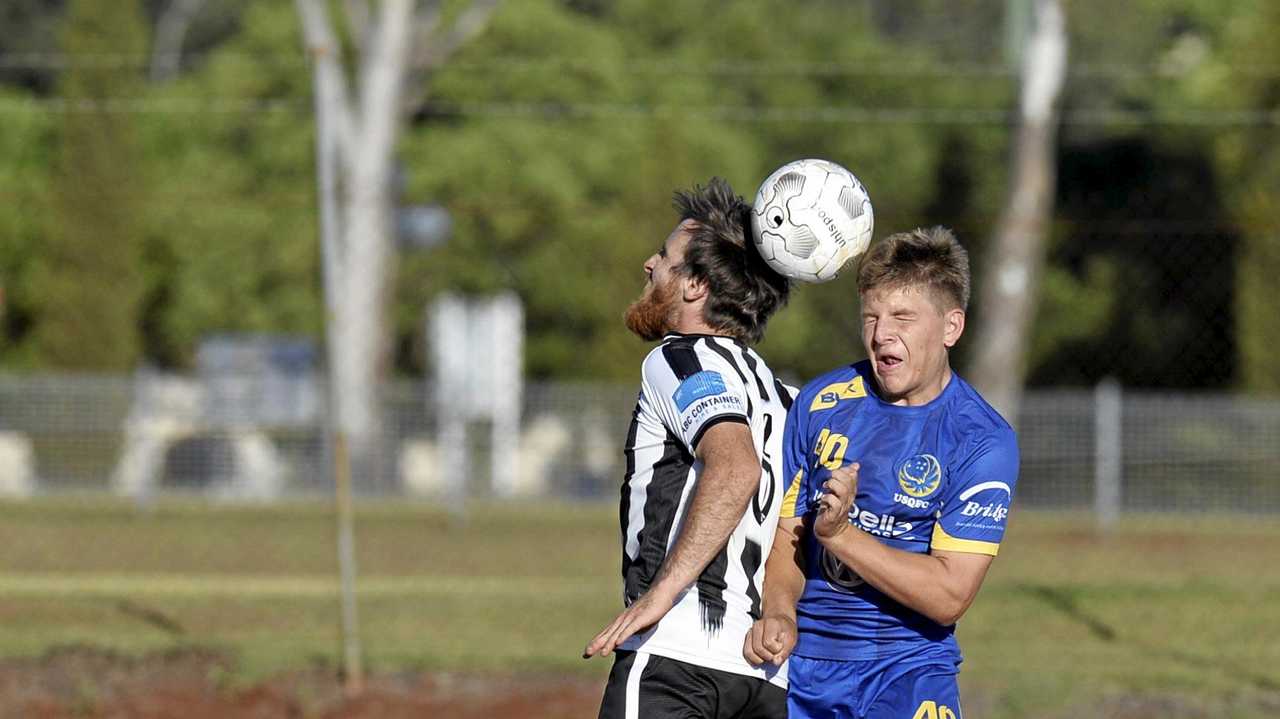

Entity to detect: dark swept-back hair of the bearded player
[673,178,791,344]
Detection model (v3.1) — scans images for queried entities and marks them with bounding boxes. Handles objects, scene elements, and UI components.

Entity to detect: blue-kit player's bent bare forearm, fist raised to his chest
[814,464,993,626]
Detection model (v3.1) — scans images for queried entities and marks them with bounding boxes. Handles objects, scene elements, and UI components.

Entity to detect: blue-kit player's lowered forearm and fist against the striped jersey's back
[742,517,804,667]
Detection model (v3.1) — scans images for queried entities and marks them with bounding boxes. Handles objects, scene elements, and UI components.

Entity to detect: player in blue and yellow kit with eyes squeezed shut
[742,228,1018,719]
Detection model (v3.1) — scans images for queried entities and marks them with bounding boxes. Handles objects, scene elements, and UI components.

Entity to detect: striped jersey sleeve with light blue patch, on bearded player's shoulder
[644,344,749,454]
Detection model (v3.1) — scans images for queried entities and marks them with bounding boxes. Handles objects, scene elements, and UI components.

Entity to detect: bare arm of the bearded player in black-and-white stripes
[582,422,760,659]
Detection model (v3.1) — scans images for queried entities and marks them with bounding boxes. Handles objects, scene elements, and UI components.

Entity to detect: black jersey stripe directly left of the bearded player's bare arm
[623,430,694,604]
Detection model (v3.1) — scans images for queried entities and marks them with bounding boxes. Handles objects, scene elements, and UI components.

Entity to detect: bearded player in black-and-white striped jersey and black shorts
[584,179,795,719]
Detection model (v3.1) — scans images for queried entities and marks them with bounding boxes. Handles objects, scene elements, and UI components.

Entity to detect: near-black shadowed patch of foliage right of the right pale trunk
[1029,137,1238,388]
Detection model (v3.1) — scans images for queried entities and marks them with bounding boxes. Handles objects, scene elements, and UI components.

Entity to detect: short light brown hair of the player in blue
[858,226,969,310]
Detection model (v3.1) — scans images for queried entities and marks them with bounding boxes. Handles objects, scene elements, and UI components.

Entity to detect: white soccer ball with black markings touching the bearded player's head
[751,160,873,283]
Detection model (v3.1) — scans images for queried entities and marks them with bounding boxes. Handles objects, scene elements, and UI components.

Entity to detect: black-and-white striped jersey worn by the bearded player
[620,334,795,686]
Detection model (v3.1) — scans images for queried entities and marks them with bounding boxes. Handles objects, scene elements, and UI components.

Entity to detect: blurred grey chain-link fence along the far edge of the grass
[0,375,1280,513]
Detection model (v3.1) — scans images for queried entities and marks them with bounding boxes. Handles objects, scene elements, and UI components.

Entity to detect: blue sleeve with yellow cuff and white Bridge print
[929,431,1019,557]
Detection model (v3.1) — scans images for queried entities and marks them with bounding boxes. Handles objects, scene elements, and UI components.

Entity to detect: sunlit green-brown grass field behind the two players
[0,499,1280,719]
